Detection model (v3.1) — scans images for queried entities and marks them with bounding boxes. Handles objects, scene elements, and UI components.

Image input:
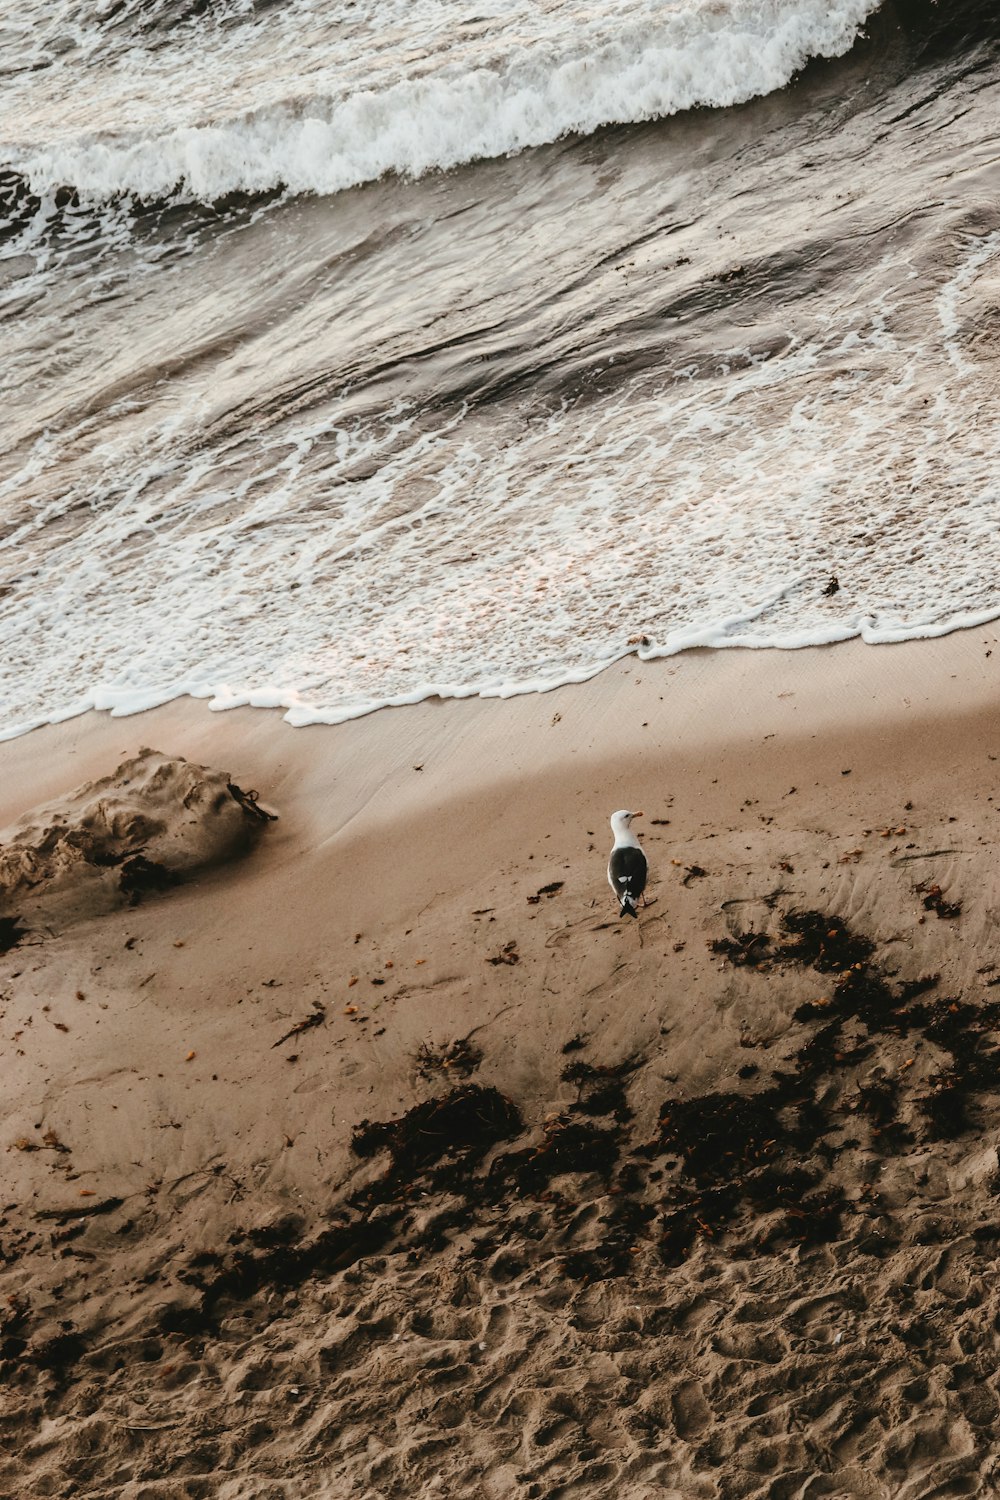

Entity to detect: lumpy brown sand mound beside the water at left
[0,750,271,947]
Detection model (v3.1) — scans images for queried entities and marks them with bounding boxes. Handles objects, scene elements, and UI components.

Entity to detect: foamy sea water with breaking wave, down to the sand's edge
[0,0,1000,737]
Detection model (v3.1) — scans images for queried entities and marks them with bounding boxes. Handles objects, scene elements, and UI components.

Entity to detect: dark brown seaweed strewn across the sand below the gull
[13,891,1000,1370]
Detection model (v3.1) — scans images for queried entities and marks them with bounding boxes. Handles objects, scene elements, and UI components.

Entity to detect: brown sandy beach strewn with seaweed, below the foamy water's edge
[0,630,1000,1500]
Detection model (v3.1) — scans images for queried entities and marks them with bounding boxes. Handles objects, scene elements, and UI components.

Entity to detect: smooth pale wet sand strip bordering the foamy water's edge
[0,624,1000,827]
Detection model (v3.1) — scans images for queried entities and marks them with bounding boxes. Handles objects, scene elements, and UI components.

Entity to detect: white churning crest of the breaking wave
[3,0,873,201]
